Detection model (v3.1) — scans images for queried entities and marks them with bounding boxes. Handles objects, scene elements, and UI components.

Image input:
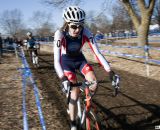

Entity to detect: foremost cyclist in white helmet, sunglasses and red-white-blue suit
[54,6,119,130]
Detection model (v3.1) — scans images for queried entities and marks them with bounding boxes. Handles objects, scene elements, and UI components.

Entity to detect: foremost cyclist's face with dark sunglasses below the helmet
[68,23,83,37]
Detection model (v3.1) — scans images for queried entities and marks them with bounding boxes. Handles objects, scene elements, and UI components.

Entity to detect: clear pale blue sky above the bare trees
[0,0,113,33]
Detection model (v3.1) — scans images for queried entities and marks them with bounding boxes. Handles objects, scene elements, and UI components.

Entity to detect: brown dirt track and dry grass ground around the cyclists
[0,43,160,130]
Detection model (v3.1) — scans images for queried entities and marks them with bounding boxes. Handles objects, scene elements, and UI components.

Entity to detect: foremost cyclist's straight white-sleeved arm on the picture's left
[53,30,64,78]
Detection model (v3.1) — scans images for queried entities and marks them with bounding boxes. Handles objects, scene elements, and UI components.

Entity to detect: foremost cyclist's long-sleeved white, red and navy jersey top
[53,28,110,78]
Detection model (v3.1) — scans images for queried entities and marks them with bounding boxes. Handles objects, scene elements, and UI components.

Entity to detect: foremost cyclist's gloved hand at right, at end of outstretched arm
[109,71,120,87]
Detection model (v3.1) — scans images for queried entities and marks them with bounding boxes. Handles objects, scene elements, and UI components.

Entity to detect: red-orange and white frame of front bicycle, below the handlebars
[68,83,100,130]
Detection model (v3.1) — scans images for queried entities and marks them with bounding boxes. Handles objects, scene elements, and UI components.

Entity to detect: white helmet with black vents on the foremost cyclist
[63,6,85,23]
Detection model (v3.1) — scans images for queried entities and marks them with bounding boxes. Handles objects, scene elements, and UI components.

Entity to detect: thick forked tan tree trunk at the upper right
[120,0,155,46]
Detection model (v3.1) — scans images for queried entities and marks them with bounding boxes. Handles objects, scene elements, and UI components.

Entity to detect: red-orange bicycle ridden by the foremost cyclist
[66,81,101,130]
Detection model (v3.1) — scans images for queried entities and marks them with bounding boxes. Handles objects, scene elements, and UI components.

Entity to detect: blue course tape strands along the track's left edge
[20,50,46,130]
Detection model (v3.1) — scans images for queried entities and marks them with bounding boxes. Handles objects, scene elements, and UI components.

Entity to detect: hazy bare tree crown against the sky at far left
[0,9,24,36]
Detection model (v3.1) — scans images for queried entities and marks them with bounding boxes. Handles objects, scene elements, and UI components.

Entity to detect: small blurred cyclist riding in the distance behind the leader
[25,32,39,67]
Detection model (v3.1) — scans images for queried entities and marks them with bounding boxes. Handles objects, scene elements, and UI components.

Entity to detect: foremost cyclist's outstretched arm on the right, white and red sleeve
[84,29,111,72]
